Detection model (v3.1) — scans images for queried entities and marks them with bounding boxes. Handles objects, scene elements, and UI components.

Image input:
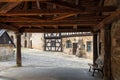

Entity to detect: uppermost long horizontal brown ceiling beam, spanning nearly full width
[0,6,116,16]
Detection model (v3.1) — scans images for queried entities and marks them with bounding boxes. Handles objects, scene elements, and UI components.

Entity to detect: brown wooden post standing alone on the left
[16,32,22,67]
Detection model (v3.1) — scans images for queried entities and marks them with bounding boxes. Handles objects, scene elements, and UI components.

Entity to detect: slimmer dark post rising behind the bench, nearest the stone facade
[93,32,98,63]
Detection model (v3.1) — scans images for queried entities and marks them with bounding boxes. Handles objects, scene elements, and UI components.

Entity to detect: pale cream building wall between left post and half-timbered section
[8,31,44,50]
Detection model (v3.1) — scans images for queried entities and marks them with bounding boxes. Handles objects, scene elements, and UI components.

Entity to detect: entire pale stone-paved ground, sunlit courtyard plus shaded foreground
[0,49,102,80]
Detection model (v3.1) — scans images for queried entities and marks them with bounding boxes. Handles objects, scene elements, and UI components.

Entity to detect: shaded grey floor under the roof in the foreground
[0,67,102,80]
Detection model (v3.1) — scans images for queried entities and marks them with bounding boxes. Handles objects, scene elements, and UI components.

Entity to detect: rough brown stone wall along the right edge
[111,20,120,80]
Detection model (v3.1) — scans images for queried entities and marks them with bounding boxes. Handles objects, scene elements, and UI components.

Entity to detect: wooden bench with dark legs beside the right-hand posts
[88,59,104,76]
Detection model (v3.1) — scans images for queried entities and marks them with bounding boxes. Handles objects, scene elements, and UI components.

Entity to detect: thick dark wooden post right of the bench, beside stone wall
[104,25,113,80]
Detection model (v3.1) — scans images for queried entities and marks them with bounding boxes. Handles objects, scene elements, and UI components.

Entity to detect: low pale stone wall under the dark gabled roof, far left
[0,44,14,61]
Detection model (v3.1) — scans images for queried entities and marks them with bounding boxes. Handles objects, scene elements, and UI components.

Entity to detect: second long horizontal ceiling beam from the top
[0,16,106,23]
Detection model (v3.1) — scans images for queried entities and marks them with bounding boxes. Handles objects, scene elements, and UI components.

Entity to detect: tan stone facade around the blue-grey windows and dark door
[62,36,93,59]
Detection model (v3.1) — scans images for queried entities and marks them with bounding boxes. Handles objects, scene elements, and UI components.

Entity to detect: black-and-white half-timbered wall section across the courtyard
[44,33,62,52]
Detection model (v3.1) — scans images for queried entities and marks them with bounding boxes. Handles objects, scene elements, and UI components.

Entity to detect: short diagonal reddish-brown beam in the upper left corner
[0,2,21,13]
